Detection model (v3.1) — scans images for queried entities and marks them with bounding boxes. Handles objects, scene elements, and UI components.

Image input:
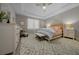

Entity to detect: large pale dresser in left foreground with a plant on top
[0,23,20,55]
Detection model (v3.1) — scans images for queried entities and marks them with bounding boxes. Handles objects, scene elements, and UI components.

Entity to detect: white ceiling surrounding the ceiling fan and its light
[13,3,79,19]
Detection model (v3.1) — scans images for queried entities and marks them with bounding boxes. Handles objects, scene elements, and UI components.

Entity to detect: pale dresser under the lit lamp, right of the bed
[63,29,75,39]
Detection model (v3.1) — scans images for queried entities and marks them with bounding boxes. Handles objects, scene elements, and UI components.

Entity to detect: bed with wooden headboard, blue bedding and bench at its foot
[35,24,63,40]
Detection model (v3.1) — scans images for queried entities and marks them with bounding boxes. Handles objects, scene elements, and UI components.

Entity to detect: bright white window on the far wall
[27,18,39,29]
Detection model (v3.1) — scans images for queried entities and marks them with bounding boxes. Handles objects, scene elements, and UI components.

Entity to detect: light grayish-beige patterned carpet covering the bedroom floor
[20,34,79,55]
